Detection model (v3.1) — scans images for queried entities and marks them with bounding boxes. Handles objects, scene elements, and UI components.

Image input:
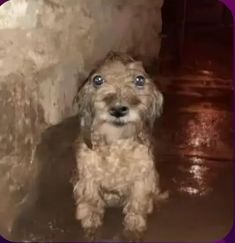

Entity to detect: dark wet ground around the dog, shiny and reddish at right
[7,27,233,242]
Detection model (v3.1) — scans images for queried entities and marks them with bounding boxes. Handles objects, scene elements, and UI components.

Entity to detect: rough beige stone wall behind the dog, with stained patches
[0,0,163,238]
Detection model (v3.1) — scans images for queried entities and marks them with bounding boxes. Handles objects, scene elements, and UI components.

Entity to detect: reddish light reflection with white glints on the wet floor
[174,106,229,196]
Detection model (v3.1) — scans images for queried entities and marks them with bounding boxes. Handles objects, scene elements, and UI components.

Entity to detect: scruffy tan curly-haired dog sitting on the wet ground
[74,54,163,240]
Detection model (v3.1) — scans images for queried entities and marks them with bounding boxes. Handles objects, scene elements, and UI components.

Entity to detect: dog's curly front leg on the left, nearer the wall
[74,180,104,240]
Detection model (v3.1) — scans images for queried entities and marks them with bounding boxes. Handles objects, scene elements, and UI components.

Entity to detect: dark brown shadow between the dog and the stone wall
[12,117,84,241]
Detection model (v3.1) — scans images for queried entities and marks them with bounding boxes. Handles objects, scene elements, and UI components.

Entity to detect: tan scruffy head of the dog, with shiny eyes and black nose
[77,53,163,141]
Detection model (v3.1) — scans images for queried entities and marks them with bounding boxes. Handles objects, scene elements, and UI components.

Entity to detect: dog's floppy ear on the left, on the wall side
[74,80,93,149]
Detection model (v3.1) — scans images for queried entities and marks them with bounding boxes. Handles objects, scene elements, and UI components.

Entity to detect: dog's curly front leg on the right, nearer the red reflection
[123,178,155,240]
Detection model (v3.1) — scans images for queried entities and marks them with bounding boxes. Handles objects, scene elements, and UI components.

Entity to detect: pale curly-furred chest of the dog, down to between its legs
[77,139,154,206]
